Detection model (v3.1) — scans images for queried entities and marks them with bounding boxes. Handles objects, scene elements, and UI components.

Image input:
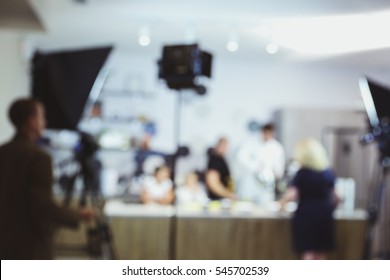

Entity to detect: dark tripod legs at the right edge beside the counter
[363,157,390,260]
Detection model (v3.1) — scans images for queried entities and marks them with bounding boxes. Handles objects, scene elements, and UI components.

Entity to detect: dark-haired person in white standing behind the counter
[237,124,285,204]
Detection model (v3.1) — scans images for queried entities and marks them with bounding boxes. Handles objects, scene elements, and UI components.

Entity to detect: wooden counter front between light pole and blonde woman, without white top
[176,218,295,260]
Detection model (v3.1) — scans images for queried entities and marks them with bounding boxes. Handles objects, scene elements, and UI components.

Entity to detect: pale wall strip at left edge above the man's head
[0,31,28,143]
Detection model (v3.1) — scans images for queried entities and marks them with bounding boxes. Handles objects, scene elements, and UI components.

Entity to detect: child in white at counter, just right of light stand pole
[176,172,209,205]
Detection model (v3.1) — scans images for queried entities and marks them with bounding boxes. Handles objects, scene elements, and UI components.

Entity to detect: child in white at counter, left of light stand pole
[141,165,174,205]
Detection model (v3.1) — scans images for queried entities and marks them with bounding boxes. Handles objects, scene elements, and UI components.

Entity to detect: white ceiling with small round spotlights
[6,0,390,70]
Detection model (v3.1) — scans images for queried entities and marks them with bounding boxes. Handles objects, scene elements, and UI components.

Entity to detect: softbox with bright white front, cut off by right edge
[359,77,390,127]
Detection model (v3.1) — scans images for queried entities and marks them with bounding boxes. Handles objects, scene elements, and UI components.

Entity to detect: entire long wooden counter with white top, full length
[57,200,366,260]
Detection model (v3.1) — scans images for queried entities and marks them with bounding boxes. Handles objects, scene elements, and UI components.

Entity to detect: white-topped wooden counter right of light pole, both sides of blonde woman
[176,210,366,260]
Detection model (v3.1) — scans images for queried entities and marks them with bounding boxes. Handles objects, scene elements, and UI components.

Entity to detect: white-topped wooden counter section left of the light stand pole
[105,201,174,260]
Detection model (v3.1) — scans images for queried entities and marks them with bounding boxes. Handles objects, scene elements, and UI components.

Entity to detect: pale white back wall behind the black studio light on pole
[101,50,363,155]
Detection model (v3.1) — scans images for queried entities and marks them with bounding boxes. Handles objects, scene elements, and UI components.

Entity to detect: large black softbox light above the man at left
[31,47,112,130]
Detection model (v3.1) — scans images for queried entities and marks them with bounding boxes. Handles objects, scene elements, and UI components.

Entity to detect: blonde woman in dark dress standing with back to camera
[280,139,338,260]
